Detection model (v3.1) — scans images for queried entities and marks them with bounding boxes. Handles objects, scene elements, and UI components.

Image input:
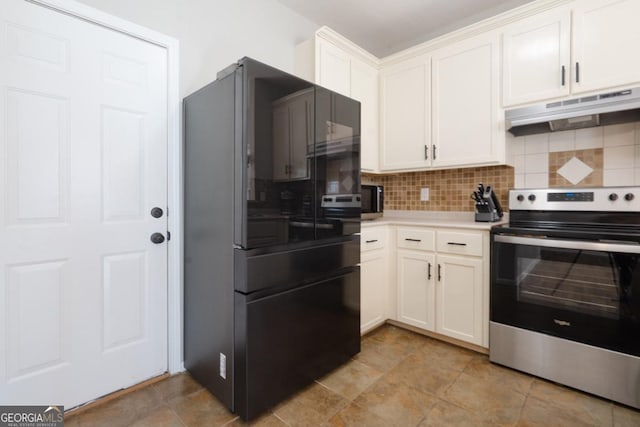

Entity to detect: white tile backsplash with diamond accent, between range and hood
[507,122,640,188]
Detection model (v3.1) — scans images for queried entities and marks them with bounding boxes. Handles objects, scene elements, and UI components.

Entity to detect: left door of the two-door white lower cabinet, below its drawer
[397,250,436,331]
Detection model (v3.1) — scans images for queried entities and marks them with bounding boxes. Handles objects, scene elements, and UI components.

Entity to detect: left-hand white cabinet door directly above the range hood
[502,8,571,106]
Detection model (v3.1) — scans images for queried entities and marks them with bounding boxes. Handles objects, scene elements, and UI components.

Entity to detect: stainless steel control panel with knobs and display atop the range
[509,186,640,212]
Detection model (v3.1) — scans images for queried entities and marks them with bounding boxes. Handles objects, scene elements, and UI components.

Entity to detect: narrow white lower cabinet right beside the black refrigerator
[360,226,391,334]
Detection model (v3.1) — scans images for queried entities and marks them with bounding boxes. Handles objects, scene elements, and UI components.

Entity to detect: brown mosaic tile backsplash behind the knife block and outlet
[362,166,514,211]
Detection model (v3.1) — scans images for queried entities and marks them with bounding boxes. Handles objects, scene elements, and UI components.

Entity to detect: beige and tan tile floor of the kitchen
[65,325,640,427]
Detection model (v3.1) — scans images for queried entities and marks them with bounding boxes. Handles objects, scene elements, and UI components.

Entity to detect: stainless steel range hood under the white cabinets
[505,88,640,136]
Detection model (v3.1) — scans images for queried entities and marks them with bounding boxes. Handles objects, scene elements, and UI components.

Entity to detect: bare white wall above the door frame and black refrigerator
[79,0,318,97]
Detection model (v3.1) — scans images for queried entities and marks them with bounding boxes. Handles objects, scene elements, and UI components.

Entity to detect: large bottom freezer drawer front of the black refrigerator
[234,267,360,419]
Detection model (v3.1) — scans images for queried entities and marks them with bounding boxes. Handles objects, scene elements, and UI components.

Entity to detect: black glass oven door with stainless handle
[491,233,640,356]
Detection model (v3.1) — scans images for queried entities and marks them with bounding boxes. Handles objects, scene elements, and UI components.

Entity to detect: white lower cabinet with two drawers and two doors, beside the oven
[396,227,489,347]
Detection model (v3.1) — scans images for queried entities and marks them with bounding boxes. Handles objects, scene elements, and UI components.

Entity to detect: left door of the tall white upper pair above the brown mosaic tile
[380,55,431,170]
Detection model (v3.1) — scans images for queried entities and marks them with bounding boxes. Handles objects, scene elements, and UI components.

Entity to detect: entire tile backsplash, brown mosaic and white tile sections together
[362,122,640,211]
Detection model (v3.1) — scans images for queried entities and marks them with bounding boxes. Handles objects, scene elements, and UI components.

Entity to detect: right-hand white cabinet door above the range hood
[572,0,640,93]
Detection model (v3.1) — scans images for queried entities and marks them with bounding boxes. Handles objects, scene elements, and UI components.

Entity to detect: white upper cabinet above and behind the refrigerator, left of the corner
[295,27,379,172]
